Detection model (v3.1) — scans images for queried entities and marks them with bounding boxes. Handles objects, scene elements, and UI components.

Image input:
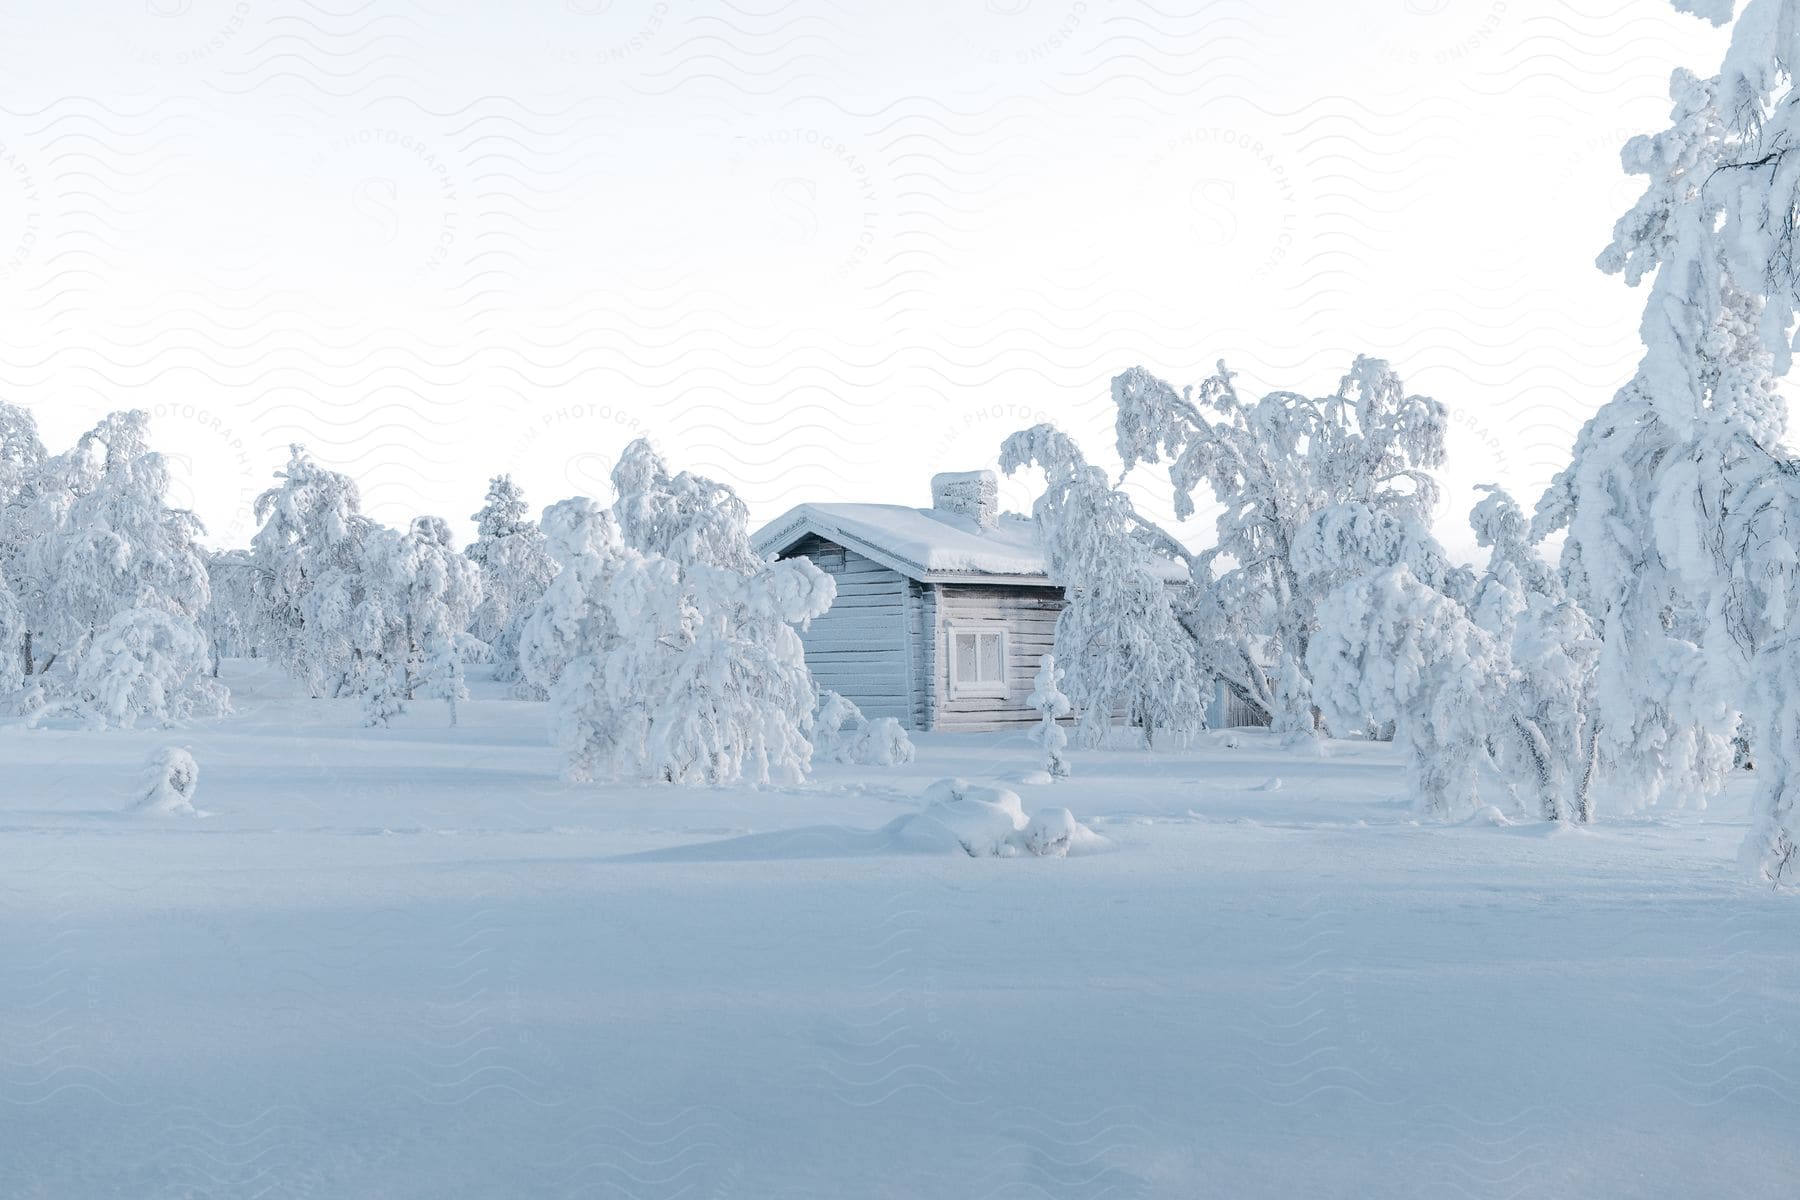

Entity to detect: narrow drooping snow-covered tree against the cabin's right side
[1001,425,1208,745]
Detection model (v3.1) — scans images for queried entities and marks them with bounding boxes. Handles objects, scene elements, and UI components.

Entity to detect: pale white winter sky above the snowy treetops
[0,0,1723,547]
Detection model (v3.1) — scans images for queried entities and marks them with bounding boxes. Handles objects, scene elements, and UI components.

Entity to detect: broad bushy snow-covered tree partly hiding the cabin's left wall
[520,443,833,783]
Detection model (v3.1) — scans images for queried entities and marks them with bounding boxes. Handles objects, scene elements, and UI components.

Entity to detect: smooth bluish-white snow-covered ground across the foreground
[0,662,1800,1200]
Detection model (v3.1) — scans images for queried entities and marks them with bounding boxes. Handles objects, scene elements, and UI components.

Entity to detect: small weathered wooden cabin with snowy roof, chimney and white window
[756,471,1209,730]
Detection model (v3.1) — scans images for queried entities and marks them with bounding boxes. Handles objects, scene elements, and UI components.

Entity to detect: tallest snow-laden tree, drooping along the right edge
[1537,0,1800,883]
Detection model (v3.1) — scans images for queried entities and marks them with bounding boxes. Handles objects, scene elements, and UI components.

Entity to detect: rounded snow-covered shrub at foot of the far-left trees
[68,608,227,729]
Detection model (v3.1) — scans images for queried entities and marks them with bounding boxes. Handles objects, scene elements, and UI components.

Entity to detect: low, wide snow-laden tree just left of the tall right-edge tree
[1292,489,1597,820]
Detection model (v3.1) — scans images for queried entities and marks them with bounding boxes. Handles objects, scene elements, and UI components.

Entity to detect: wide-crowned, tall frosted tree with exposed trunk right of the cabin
[1112,356,1445,739]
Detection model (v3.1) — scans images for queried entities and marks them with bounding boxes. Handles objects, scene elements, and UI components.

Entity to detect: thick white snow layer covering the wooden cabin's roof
[754,504,1186,587]
